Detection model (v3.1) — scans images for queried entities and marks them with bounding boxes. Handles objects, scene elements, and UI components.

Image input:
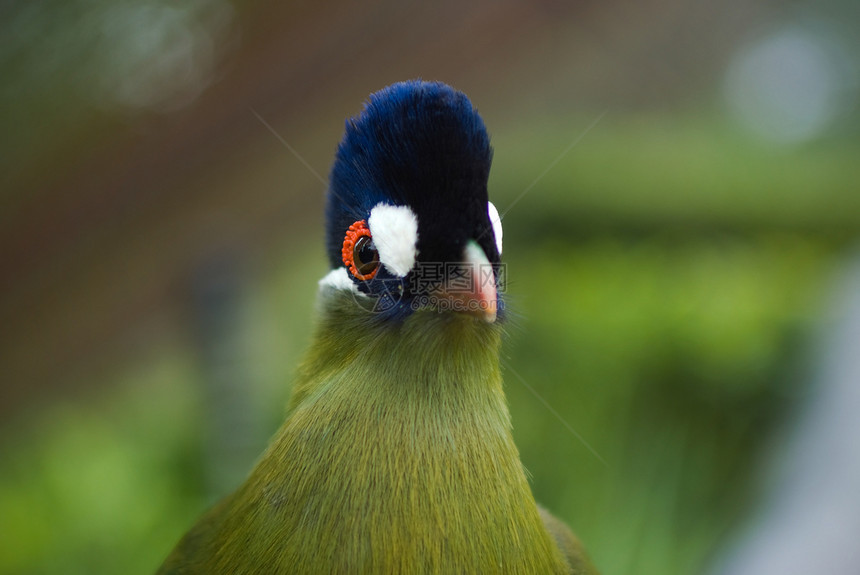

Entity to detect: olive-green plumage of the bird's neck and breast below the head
[159,288,594,575]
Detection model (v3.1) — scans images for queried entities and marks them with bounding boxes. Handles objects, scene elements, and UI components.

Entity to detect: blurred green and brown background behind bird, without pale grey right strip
[0,0,860,575]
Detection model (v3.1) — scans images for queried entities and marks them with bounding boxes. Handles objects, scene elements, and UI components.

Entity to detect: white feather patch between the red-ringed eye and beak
[367,203,418,277]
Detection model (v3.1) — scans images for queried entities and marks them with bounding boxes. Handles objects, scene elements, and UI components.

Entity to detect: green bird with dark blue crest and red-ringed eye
[158,80,597,575]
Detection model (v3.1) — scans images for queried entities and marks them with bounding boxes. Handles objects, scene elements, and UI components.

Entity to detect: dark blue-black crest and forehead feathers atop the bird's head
[326,80,499,267]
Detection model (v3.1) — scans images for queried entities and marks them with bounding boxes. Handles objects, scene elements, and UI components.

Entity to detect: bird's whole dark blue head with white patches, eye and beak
[321,80,502,323]
